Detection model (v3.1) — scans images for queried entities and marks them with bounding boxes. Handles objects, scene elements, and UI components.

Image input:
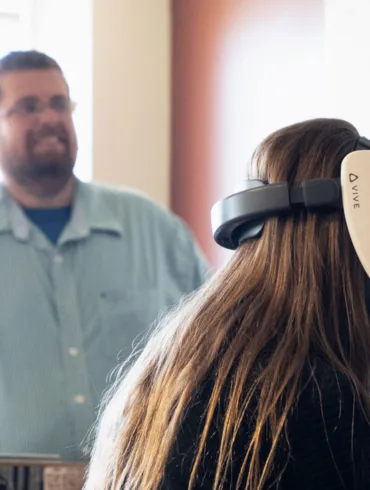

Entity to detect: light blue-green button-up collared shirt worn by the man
[0,182,207,460]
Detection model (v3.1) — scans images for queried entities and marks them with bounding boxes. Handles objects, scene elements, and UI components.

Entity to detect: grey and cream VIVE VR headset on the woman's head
[211,137,370,276]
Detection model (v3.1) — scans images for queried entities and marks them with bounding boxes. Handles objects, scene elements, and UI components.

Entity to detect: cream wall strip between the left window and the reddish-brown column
[94,0,171,205]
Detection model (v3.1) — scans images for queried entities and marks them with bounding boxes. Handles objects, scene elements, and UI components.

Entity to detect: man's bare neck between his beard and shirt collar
[5,177,76,209]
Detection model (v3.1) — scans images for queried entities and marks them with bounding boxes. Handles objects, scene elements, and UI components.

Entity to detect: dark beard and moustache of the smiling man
[3,126,75,197]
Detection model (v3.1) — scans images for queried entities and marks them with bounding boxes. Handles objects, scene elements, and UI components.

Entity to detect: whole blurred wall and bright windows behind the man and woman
[0,0,370,265]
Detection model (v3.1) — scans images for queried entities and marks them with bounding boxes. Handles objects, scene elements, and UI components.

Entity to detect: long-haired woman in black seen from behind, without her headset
[85,119,370,490]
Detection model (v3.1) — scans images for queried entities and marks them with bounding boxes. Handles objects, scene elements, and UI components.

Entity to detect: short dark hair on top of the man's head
[0,50,68,97]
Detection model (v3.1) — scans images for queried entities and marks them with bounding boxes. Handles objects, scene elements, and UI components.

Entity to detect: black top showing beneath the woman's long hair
[161,365,370,490]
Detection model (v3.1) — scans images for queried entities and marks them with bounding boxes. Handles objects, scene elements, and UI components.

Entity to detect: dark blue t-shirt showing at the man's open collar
[23,206,71,245]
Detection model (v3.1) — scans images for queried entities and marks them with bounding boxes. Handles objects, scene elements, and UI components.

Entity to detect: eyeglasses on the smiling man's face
[0,95,76,117]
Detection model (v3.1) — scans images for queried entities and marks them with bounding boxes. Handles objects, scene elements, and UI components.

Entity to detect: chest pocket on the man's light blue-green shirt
[99,289,161,361]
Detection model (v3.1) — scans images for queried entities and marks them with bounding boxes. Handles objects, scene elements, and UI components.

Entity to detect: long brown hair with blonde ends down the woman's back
[86,119,370,490]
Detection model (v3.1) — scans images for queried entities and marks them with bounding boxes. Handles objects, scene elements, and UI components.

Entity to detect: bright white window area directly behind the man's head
[0,0,93,181]
